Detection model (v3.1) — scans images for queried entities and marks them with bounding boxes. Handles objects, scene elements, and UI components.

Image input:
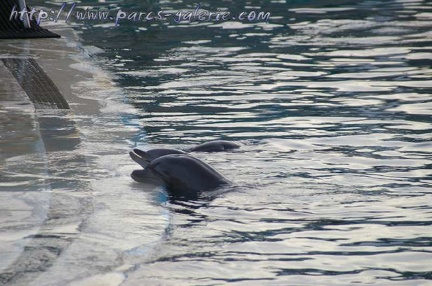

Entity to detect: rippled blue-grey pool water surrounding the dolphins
[0,0,432,285]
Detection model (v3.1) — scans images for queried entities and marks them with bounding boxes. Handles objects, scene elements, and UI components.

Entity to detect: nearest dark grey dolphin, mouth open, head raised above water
[131,154,230,198]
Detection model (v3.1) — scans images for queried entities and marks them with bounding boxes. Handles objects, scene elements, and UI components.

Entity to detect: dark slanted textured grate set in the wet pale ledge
[2,58,69,109]
